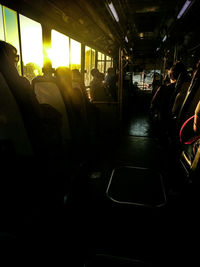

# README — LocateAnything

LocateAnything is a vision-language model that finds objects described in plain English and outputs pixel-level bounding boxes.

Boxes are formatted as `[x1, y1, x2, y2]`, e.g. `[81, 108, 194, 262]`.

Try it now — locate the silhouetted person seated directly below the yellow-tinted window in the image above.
[90, 69, 110, 101]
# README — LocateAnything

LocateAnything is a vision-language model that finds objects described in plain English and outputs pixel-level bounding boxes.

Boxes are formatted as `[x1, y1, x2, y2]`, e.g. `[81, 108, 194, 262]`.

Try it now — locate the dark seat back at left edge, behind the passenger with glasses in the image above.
[0, 73, 33, 156]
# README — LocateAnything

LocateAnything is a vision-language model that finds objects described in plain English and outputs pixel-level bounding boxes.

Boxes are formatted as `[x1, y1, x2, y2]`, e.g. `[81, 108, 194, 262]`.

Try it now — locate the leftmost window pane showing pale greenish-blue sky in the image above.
[3, 7, 21, 74]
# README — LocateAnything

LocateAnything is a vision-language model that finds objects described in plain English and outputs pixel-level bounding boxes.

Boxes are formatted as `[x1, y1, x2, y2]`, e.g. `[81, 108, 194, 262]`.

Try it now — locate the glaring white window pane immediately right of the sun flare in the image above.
[50, 30, 69, 68]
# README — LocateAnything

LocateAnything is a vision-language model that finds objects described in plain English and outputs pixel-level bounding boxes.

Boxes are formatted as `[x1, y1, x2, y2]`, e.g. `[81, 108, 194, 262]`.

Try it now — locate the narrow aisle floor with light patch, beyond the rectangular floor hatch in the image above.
[115, 91, 164, 170]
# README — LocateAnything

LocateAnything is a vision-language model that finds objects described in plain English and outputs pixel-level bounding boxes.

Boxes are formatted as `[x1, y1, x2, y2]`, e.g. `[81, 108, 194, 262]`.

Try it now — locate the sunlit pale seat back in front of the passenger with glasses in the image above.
[32, 78, 71, 148]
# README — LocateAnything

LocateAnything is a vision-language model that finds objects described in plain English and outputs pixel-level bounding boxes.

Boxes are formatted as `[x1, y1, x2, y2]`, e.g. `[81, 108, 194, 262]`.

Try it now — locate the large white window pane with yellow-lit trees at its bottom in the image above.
[20, 15, 43, 81]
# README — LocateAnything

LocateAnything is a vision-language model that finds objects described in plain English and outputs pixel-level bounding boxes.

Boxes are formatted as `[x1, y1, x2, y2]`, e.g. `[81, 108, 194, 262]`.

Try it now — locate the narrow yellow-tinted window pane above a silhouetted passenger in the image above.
[85, 46, 95, 86]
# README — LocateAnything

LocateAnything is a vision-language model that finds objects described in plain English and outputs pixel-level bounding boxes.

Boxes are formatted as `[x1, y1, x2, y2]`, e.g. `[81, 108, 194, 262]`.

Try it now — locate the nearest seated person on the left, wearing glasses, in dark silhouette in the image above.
[0, 41, 62, 156]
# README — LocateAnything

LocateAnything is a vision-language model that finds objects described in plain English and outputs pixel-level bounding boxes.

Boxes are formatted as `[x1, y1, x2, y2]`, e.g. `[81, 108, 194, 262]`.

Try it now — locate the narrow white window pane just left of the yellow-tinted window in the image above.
[70, 39, 81, 70]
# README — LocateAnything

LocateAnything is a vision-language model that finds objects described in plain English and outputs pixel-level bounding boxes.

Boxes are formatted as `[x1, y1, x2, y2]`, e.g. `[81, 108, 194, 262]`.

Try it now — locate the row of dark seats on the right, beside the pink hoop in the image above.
[155, 62, 200, 184]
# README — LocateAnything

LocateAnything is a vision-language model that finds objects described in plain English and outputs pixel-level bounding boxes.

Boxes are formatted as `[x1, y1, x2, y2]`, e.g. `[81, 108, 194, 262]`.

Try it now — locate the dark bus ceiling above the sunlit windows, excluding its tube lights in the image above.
[2, 0, 200, 63]
